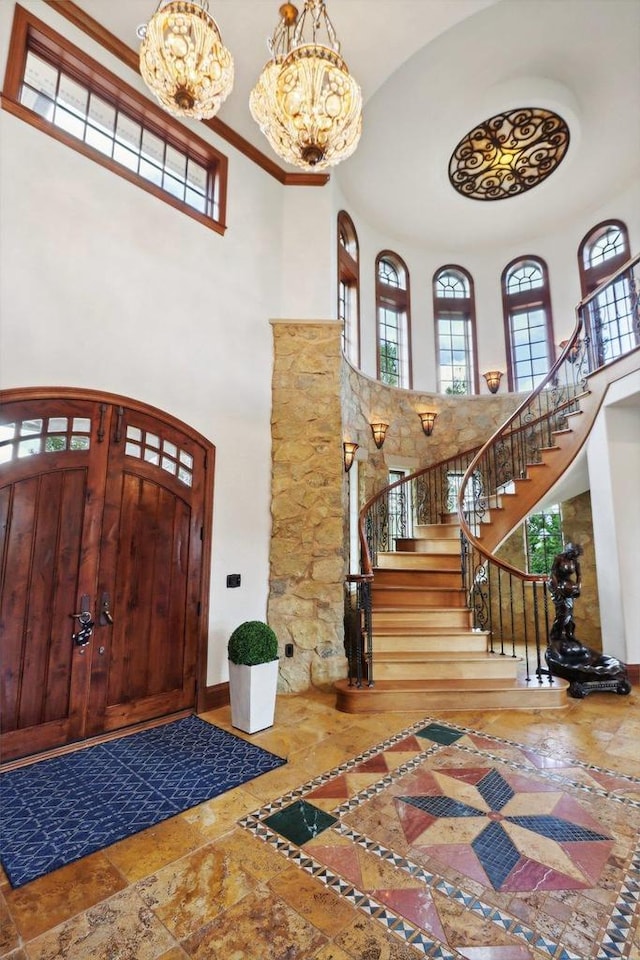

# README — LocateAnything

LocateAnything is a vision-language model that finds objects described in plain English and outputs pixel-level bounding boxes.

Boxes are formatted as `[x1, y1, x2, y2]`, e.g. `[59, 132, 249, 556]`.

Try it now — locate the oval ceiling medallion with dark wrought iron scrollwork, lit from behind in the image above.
[449, 107, 569, 200]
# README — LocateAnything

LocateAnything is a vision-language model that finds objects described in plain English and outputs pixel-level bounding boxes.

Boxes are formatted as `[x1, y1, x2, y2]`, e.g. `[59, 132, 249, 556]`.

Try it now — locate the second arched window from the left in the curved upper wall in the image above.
[376, 250, 411, 387]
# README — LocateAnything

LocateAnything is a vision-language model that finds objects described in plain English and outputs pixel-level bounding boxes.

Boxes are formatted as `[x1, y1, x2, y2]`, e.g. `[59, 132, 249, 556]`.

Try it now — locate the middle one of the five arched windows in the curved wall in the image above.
[433, 266, 478, 394]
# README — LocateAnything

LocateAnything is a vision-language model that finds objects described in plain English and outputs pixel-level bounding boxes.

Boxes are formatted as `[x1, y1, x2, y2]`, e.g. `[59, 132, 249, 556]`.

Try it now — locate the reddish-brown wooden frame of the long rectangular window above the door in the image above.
[1, 5, 228, 234]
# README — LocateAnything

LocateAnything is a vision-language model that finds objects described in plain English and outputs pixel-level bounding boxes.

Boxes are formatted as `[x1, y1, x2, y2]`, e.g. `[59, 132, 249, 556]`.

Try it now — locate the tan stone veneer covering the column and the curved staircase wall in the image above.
[267, 338, 599, 692]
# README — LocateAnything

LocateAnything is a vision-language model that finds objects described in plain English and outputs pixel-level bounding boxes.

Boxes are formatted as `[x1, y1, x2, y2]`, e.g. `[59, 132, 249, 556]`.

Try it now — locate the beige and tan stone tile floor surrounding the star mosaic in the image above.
[0, 690, 640, 960]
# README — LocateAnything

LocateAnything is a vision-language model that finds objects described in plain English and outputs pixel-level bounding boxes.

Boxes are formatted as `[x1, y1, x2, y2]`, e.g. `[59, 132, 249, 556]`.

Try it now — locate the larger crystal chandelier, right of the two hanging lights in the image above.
[249, 0, 362, 170]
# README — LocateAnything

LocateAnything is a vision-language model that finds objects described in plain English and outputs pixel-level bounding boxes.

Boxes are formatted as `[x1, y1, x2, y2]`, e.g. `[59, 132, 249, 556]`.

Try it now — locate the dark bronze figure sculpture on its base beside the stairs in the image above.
[545, 543, 631, 699]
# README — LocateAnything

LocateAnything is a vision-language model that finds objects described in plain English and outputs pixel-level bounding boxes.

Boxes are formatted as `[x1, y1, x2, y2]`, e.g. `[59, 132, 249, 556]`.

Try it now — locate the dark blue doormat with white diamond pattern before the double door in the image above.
[0, 716, 286, 888]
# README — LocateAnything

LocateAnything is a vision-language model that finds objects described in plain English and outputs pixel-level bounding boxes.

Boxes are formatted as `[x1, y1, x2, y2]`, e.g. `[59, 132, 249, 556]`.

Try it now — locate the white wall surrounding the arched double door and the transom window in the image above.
[0, 3, 284, 683]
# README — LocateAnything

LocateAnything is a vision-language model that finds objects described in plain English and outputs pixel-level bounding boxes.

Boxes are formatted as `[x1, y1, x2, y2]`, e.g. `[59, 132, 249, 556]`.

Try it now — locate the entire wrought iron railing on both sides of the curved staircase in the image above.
[345, 257, 640, 686]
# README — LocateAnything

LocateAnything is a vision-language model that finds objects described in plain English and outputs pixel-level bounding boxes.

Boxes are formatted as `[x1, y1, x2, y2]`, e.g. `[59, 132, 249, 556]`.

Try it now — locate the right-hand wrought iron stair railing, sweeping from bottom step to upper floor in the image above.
[457, 251, 640, 683]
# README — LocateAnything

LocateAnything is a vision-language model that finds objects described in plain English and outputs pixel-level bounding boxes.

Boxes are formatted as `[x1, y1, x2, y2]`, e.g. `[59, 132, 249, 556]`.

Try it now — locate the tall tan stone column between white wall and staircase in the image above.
[267, 320, 347, 692]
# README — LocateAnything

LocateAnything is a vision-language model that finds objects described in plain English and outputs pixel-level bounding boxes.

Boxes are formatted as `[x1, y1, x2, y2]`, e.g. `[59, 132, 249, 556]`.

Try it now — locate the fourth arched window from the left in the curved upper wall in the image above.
[502, 257, 555, 391]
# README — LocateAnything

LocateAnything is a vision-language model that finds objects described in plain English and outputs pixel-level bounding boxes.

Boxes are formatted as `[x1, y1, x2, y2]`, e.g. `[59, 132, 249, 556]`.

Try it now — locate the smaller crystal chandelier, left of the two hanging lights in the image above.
[138, 0, 233, 120]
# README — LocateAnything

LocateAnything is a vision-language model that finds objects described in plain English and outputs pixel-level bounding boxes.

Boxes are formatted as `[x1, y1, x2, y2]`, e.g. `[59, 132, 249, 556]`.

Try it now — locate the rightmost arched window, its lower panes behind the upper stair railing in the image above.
[578, 220, 638, 364]
